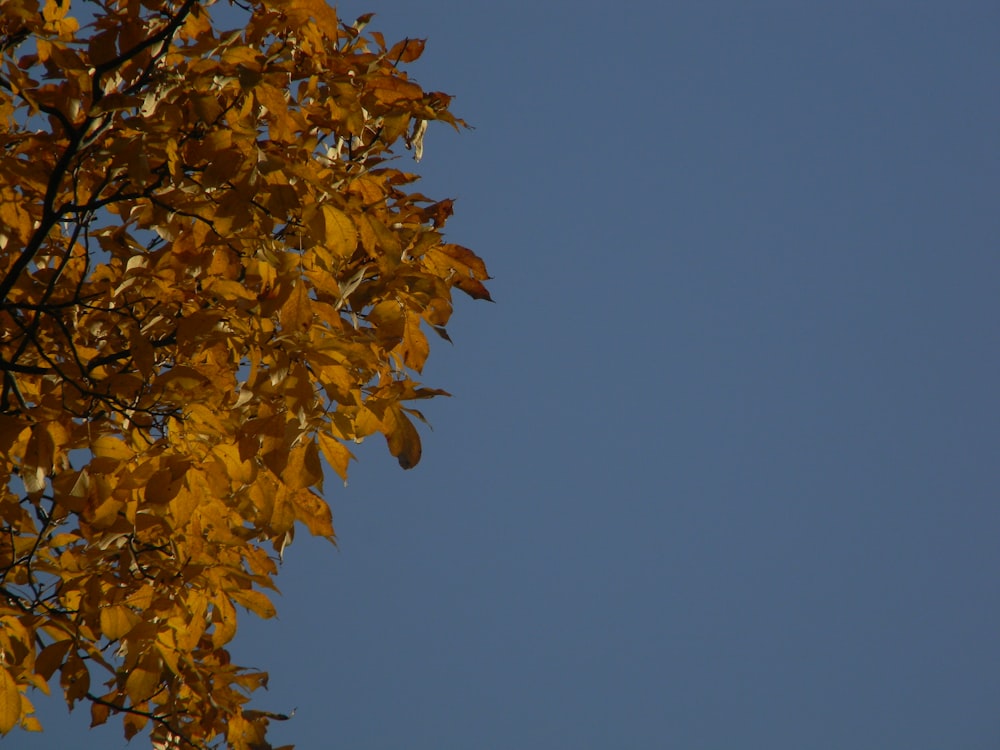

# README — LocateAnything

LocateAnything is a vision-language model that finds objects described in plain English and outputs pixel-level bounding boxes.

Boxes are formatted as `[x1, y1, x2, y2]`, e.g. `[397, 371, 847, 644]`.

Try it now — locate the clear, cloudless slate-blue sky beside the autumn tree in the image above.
[19, 0, 1000, 750]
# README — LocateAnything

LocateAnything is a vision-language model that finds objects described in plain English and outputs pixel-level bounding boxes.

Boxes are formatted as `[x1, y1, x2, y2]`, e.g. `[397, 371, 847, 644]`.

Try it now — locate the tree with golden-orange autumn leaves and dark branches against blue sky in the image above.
[0, 0, 489, 749]
